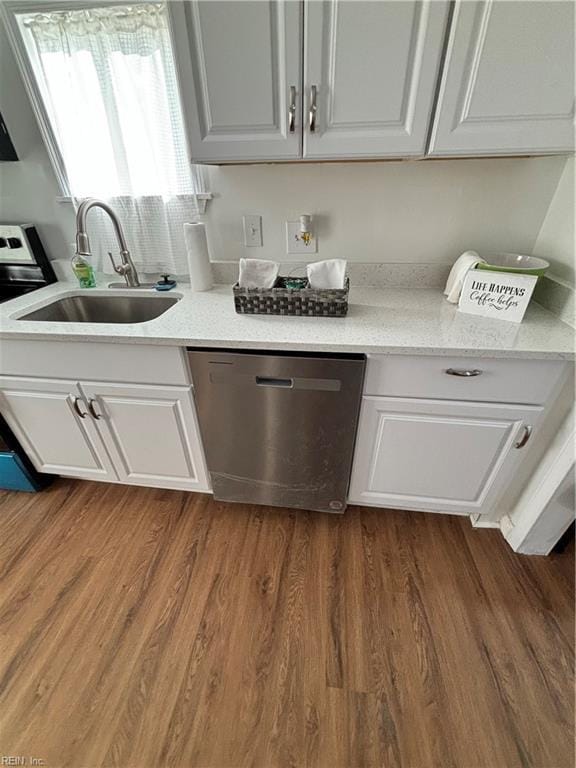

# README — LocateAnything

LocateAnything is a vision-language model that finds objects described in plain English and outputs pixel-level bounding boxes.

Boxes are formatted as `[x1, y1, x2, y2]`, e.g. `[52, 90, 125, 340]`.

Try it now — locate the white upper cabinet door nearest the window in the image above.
[169, 0, 302, 163]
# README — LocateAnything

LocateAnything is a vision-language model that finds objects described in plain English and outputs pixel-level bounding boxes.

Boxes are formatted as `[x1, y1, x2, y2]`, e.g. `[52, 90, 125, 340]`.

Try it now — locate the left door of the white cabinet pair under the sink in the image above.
[0, 376, 118, 481]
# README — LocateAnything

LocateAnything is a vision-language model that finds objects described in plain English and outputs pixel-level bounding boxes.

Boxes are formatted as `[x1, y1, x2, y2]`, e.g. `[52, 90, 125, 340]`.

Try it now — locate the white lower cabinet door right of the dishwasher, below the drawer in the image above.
[349, 397, 542, 514]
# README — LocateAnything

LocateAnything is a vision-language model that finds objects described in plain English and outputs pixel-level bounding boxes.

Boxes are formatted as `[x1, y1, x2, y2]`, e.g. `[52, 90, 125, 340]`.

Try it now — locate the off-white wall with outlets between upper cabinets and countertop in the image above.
[206, 157, 565, 263]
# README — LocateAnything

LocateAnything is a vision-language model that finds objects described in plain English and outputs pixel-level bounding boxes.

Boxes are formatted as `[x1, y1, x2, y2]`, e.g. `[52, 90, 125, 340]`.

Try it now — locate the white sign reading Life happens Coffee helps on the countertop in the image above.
[458, 269, 538, 323]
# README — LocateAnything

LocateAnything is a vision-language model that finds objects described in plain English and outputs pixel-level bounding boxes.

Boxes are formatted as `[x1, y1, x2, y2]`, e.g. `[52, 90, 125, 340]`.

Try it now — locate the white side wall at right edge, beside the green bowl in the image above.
[533, 157, 576, 287]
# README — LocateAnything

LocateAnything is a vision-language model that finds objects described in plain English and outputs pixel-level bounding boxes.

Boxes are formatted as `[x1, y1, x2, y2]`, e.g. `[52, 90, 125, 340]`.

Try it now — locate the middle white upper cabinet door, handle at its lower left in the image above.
[304, 0, 448, 159]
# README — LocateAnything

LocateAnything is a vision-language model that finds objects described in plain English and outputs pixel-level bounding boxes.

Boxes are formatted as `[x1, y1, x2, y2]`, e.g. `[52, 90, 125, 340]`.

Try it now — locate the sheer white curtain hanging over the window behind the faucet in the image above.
[21, 3, 205, 275]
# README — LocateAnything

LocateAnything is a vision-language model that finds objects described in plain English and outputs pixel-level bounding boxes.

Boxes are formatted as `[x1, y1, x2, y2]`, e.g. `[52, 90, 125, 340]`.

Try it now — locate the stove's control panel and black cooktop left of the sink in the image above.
[0, 224, 57, 303]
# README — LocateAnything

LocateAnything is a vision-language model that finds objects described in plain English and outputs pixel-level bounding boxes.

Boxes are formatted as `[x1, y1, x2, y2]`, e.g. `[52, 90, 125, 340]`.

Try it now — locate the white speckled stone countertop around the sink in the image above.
[0, 283, 575, 360]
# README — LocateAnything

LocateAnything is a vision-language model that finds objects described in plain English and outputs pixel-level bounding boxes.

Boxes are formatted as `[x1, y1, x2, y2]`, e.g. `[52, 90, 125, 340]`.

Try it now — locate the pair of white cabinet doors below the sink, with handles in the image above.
[0, 376, 210, 491]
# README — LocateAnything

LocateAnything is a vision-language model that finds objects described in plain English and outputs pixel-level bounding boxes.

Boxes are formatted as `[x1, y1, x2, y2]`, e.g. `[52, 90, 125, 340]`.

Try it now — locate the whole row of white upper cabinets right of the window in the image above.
[169, 0, 574, 163]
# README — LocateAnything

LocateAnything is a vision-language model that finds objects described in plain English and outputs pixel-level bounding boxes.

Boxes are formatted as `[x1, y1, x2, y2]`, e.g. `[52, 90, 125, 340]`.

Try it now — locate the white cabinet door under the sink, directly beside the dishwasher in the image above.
[81, 382, 210, 491]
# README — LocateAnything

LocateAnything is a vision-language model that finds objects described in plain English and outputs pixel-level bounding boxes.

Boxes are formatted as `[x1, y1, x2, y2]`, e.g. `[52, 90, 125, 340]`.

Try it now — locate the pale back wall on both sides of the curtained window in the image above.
[0, 18, 565, 272]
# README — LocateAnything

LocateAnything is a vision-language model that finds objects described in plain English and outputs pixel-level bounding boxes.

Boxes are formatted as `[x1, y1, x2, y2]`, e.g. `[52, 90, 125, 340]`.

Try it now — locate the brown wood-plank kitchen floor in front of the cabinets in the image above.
[0, 480, 574, 768]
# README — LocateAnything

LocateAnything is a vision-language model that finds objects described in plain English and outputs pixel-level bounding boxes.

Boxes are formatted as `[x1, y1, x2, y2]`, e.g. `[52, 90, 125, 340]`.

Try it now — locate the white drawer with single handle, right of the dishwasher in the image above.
[364, 355, 566, 405]
